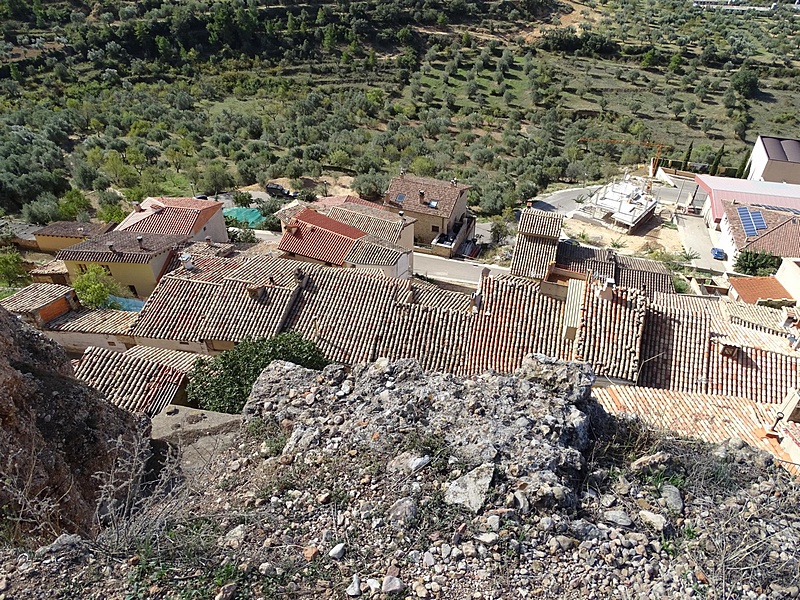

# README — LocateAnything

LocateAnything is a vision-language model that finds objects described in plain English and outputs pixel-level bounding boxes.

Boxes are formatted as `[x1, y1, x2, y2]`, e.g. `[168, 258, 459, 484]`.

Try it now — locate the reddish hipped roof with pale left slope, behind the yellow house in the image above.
[117, 198, 222, 237]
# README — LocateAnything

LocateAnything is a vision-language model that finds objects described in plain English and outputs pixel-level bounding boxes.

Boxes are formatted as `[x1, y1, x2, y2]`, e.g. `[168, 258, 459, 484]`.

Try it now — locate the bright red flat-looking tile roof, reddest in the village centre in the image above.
[278, 209, 366, 266]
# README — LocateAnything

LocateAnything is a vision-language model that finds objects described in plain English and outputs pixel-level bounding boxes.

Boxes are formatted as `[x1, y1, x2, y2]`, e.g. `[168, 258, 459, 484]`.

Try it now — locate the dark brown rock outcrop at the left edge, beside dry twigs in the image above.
[0, 308, 142, 535]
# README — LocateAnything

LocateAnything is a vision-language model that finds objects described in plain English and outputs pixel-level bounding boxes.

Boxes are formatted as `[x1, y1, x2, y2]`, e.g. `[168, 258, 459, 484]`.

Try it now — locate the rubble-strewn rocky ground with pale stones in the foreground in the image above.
[0, 356, 800, 600]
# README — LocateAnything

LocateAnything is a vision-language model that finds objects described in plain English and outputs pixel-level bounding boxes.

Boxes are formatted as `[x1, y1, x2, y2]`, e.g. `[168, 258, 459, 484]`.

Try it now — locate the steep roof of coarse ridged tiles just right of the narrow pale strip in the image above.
[574, 283, 648, 382]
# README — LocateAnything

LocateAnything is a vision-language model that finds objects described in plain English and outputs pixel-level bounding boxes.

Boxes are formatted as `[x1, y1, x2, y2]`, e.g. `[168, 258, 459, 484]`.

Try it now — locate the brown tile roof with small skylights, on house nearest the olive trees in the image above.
[384, 175, 471, 219]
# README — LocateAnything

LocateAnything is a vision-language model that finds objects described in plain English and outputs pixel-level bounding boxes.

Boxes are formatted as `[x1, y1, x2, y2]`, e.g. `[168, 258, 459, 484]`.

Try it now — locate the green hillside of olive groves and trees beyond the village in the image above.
[0, 0, 800, 220]
